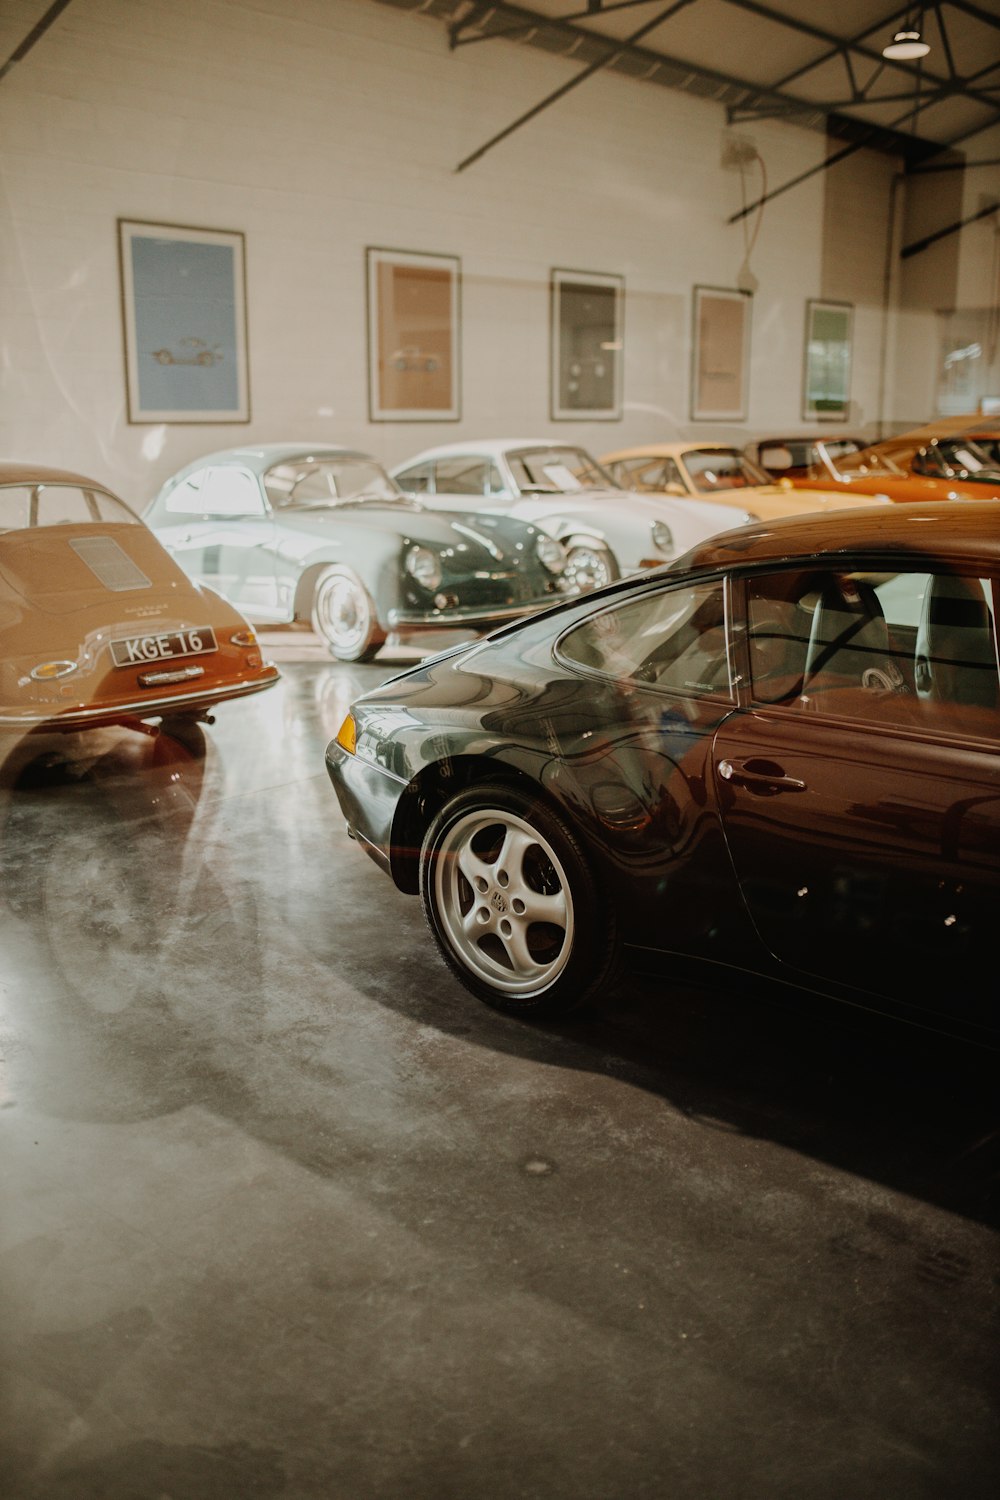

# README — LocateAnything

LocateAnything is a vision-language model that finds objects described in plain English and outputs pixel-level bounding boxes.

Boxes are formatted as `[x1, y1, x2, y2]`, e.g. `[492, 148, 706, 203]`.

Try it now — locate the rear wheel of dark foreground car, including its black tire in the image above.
[420, 782, 618, 1017]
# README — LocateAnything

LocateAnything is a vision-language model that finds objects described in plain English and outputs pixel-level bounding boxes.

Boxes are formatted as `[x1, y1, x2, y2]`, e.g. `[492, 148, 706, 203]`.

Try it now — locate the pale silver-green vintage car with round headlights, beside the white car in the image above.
[144, 443, 565, 662]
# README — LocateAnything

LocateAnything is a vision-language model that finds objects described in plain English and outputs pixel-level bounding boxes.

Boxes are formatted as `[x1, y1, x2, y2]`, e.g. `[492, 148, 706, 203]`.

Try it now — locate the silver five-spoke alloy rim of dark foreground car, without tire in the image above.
[432, 807, 574, 996]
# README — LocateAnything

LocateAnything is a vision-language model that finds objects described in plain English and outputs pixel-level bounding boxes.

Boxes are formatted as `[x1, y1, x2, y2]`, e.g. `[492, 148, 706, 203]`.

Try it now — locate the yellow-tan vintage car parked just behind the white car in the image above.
[601, 441, 885, 521]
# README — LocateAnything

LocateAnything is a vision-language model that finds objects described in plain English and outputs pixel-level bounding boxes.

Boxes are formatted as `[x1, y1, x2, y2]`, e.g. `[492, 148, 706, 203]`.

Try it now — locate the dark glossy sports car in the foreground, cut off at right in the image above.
[327, 501, 1000, 1046]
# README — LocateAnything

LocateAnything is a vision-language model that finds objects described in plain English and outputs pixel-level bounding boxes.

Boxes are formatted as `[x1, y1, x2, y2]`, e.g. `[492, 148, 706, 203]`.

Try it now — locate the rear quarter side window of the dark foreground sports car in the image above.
[558, 581, 733, 699]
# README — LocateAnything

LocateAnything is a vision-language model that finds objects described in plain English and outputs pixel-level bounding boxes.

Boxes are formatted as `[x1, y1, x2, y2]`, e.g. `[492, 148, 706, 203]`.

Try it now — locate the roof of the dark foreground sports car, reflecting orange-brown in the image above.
[682, 500, 1000, 570]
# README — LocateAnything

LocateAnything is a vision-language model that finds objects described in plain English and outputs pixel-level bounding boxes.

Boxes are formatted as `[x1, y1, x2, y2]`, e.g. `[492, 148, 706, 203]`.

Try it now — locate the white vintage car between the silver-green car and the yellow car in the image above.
[391, 438, 757, 590]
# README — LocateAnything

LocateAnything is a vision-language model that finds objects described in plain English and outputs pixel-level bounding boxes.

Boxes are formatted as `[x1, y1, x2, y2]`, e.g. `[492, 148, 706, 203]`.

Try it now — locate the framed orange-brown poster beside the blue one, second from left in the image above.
[366, 246, 462, 422]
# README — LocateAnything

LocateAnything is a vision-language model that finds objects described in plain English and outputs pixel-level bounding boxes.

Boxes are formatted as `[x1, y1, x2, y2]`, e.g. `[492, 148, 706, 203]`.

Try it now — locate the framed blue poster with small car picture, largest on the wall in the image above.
[118, 219, 250, 423]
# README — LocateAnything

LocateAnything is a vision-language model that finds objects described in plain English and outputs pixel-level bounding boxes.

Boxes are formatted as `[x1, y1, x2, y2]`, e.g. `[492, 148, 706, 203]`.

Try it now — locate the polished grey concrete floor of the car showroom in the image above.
[0, 632, 1000, 1500]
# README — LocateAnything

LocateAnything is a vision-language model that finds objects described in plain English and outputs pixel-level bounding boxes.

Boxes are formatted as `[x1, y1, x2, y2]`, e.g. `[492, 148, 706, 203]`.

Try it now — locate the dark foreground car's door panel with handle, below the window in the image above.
[714, 708, 1000, 1022]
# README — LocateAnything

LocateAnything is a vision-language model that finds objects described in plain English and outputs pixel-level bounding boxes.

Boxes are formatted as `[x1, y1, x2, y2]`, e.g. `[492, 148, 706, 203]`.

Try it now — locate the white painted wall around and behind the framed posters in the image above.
[0, 0, 983, 503]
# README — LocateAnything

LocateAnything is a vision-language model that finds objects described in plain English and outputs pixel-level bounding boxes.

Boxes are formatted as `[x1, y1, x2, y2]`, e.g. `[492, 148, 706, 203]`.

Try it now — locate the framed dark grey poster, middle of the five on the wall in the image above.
[550, 270, 625, 422]
